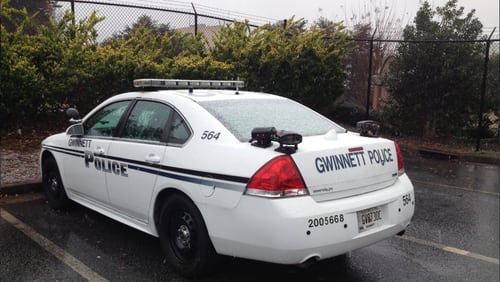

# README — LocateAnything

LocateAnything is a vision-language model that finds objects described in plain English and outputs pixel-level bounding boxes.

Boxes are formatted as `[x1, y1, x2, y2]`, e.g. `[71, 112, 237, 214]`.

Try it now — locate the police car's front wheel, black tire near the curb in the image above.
[42, 157, 71, 210]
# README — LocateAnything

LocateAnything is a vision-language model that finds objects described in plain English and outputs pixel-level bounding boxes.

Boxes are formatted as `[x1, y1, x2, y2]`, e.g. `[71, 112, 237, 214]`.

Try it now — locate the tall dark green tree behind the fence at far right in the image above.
[386, 0, 483, 137]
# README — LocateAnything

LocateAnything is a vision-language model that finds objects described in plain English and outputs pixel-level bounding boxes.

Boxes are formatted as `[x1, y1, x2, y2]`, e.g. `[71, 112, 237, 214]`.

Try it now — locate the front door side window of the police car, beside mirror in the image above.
[84, 101, 130, 137]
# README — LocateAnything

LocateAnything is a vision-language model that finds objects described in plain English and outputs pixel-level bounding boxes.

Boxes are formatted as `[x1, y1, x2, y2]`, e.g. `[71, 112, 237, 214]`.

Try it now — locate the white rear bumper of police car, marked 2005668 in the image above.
[202, 175, 415, 264]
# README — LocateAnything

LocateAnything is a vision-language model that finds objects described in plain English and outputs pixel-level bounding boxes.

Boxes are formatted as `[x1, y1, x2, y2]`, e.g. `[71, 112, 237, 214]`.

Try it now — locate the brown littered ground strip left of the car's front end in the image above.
[0, 148, 41, 187]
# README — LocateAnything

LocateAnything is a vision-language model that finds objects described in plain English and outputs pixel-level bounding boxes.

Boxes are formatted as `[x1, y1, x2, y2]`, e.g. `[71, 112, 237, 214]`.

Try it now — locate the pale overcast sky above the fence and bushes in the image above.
[187, 0, 499, 33]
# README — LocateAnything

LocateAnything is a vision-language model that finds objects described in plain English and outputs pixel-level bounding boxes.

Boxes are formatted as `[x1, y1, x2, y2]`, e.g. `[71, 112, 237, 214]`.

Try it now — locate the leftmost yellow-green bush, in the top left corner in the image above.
[0, 5, 102, 125]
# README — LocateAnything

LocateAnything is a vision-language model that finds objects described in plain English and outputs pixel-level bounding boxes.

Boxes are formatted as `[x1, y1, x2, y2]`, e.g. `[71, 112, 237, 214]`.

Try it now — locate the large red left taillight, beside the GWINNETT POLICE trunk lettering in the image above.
[245, 155, 307, 198]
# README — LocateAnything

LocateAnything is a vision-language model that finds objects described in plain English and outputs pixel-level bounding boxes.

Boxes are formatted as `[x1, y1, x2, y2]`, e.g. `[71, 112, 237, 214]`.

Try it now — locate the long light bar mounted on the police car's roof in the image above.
[134, 78, 245, 89]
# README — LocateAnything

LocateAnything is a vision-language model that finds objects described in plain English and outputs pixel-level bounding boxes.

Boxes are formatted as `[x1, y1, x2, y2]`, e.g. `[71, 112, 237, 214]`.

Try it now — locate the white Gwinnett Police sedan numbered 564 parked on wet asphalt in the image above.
[40, 79, 415, 277]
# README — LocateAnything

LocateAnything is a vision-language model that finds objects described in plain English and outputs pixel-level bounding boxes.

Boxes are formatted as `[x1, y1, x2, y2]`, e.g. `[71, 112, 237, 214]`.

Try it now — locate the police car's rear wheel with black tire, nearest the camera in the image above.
[159, 194, 217, 278]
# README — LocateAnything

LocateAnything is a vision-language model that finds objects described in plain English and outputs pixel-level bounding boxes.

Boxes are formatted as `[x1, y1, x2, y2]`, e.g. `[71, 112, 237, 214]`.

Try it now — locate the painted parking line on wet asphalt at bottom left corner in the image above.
[0, 209, 108, 281]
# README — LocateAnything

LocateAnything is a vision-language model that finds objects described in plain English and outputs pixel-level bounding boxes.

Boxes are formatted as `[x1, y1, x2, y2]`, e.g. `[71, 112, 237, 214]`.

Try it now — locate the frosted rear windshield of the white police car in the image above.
[200, 99, 345, 142]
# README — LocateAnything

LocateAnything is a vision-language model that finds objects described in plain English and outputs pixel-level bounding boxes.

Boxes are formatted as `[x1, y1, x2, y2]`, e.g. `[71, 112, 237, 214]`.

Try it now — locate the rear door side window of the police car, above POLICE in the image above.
[122, 101, 172, 142]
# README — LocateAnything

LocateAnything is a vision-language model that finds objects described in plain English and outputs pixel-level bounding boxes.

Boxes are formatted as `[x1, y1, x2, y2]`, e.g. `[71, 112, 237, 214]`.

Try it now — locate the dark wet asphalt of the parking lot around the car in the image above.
[0, 155, 500, 281]
